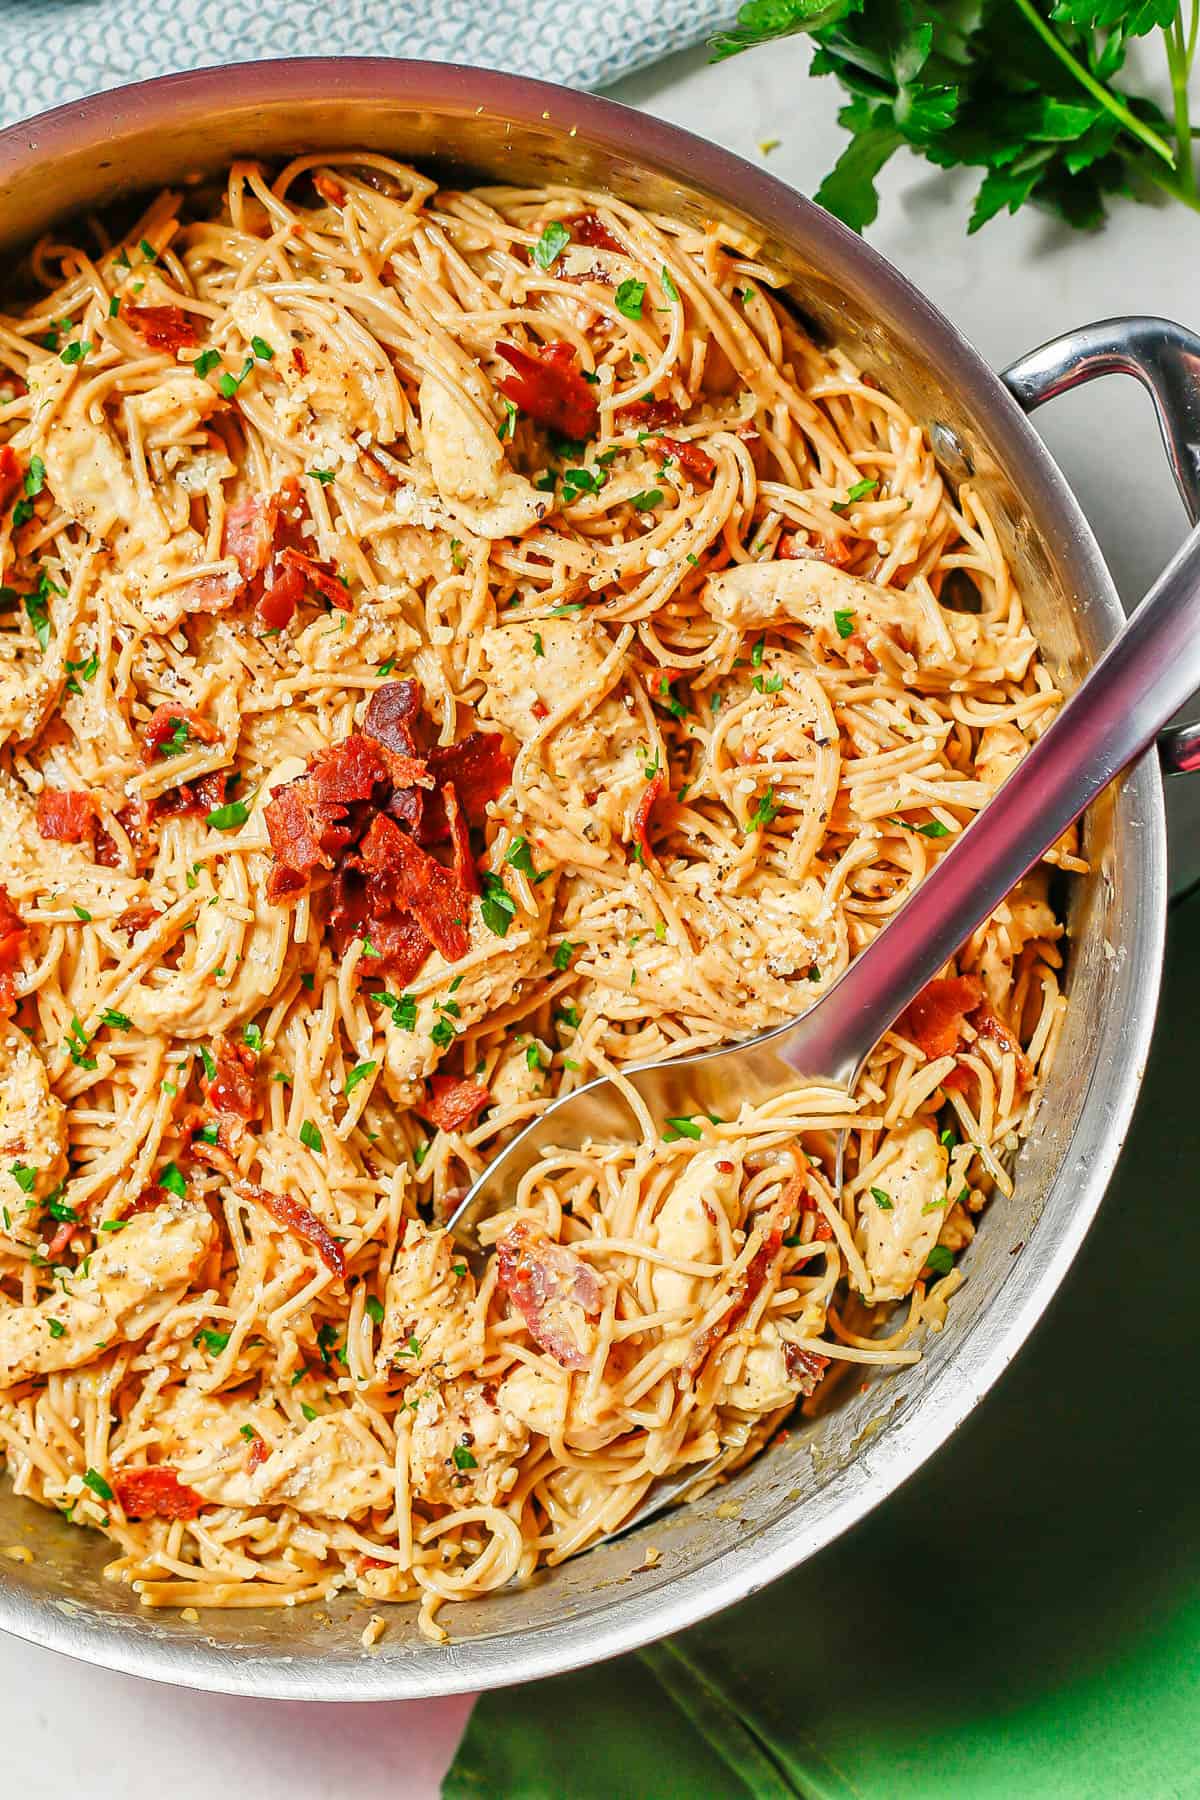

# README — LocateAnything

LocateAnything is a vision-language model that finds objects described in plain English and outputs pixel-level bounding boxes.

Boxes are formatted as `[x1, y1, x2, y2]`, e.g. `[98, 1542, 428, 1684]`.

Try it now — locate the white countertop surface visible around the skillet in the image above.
[0, 38, 1200, 1800]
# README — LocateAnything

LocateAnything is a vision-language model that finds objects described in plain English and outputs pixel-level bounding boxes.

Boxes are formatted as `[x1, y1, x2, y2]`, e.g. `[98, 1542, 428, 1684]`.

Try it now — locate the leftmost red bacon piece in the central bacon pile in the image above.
[263, 731, 387, 902]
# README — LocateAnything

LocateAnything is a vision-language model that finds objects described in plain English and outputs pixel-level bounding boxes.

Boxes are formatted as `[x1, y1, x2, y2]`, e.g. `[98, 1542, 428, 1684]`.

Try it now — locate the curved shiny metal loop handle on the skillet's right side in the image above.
[1000, 319, 1200, 776]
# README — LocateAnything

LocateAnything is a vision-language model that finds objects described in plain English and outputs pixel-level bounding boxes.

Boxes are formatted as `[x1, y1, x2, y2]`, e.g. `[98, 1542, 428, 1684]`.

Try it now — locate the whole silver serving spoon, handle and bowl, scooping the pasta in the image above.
[450, 527, 1200, 1532]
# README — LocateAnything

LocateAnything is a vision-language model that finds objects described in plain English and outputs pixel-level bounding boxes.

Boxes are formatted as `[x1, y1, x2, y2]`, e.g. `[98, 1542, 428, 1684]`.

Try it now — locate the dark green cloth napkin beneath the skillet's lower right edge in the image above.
[443, 898, 1200, 1800]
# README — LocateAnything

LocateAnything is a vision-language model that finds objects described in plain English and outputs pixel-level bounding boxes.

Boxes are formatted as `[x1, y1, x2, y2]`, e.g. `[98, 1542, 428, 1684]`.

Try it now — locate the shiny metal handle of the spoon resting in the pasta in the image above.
[772, 527, 1200, 1080]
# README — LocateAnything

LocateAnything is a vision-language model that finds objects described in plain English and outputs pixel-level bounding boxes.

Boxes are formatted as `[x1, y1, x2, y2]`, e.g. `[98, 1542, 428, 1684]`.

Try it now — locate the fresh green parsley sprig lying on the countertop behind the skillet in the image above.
[712, 0, 1200, 232]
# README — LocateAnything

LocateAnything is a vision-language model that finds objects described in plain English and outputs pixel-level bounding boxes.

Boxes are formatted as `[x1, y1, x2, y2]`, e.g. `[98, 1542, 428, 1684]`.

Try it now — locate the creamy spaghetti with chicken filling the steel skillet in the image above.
[0, 153, 1083, 1636]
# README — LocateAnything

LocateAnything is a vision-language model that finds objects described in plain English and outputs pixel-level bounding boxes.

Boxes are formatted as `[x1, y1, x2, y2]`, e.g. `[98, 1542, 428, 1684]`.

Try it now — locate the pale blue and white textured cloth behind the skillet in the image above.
[0, 0, 738, 124]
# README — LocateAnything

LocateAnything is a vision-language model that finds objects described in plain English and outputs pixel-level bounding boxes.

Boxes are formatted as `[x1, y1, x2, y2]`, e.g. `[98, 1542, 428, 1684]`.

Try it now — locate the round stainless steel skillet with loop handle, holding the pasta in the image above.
[0, 59, 1200, 1699]
